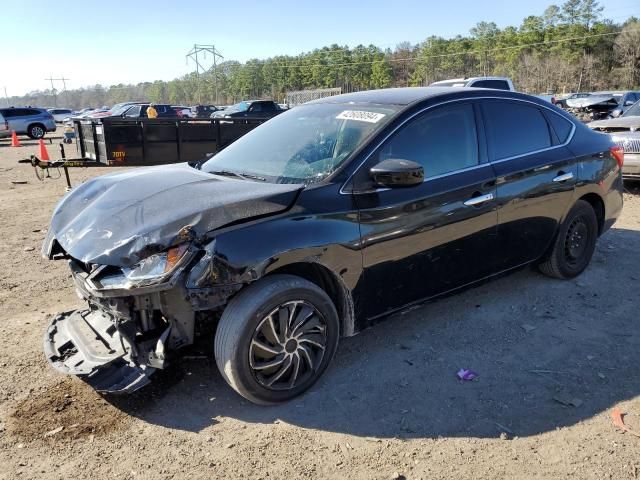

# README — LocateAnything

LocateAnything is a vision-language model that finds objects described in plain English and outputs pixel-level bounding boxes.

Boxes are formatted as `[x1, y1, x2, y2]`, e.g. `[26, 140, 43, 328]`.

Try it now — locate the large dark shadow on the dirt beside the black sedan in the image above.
[109, 229, 640, 438]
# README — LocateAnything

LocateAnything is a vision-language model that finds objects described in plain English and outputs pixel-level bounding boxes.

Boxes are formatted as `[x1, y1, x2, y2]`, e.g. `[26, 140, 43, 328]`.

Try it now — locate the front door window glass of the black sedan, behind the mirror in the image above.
[378, 104, 479, 178]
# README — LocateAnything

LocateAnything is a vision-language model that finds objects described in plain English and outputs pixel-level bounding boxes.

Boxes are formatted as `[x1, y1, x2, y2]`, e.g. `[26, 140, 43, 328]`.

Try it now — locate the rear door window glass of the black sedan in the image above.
[483, 101, 552, 160]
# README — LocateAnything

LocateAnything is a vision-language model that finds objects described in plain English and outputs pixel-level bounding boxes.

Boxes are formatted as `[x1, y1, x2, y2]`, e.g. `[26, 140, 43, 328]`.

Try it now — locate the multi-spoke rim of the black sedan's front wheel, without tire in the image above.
[249, 300, 327, 390]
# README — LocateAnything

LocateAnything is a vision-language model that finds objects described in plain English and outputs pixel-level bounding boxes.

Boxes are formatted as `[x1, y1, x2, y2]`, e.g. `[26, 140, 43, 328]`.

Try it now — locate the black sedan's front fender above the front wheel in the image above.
[187, 184, 363, 336]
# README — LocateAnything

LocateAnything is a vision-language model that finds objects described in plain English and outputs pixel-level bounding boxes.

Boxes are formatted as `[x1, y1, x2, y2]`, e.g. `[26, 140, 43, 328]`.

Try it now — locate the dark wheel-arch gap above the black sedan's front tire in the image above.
[265, 262, 355, 337]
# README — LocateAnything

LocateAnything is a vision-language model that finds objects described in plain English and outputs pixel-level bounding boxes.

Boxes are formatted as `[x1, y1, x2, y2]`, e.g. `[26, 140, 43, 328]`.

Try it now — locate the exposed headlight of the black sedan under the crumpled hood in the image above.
[88, 243, 189, 290]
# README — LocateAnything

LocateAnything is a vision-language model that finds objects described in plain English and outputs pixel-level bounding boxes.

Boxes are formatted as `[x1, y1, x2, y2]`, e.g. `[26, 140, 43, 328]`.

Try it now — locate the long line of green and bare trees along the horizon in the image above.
[8, 0, 640, 109]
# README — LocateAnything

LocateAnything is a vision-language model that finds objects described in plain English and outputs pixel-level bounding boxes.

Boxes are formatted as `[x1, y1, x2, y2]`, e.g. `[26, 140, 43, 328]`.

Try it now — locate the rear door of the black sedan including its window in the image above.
[482, 99, 577, 269]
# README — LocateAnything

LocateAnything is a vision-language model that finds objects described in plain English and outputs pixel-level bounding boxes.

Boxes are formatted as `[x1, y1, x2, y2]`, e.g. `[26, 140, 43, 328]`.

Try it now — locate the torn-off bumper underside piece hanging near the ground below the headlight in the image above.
[44, 310, 161, 393]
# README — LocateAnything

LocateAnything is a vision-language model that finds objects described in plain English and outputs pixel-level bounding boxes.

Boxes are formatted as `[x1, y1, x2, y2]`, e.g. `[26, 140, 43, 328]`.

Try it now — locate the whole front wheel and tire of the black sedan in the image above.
[215, 275, 339, 405]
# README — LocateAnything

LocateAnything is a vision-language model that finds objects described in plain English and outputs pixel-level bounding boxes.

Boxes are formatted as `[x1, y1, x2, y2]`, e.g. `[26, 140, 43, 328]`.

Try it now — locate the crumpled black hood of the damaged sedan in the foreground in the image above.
[43, 163, 302, 267]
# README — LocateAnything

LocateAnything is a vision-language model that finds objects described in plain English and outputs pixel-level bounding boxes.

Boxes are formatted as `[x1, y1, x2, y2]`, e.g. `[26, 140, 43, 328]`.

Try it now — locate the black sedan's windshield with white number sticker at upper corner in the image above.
[202, 104, 398, 185]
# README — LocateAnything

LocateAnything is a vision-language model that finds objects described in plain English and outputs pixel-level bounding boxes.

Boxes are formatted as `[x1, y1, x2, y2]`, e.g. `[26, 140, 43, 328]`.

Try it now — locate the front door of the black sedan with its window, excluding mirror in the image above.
[354, 102, 497, 318]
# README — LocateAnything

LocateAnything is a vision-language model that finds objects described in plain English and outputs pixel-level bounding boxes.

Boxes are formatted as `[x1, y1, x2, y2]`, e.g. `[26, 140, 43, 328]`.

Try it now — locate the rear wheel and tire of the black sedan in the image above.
[538, 200, 598, 279]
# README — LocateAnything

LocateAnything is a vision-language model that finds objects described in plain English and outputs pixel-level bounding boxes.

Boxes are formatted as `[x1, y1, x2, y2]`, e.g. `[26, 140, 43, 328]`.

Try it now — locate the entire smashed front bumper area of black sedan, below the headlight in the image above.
[44, 251, 240, 393]
